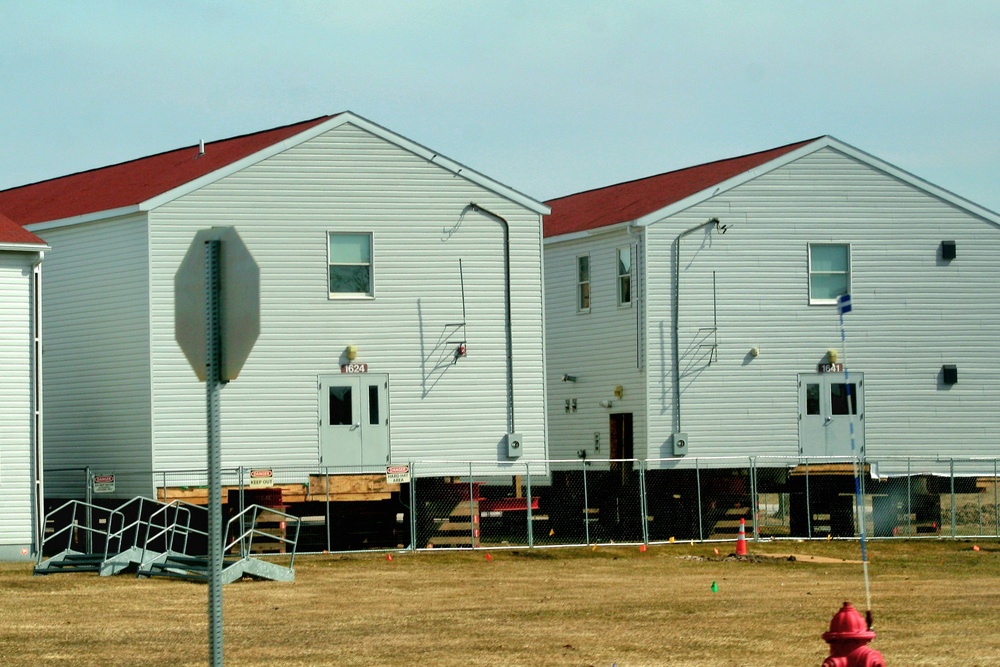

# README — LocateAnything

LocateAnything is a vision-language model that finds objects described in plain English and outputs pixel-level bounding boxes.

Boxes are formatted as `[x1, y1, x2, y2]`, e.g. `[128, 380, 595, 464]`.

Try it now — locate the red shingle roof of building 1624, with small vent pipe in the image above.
[0, 116, 332, 225]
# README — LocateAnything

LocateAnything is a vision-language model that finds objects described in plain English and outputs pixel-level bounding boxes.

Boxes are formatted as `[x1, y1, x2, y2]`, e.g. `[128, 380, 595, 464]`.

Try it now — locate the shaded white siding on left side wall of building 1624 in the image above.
[39, 215, 154, 498]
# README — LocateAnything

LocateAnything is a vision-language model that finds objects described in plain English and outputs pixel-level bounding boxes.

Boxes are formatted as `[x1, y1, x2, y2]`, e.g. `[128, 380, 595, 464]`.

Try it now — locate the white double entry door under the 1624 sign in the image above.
[319, 374, 389, 468]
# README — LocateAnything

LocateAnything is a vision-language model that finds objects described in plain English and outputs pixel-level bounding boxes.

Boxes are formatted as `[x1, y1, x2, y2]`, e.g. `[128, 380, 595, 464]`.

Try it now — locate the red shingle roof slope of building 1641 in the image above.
[544, 139, 815, 237]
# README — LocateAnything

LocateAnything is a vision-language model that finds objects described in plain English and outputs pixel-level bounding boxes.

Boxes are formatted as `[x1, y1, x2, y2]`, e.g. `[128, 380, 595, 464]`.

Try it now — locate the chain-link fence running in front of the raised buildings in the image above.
[39, 457, 1000, 553]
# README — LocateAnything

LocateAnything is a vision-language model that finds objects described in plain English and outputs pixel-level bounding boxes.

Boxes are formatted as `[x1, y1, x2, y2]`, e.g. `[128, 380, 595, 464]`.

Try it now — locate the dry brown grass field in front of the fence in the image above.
[0, 540, 1000, 667]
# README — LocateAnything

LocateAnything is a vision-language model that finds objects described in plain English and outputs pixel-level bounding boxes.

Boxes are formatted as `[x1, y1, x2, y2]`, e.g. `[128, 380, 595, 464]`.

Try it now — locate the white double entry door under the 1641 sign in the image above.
[799, 373, 865, 456]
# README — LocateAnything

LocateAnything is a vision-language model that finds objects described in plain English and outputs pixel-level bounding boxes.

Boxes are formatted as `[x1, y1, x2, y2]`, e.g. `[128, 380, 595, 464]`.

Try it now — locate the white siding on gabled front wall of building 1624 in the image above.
[150, 124, 546, 470]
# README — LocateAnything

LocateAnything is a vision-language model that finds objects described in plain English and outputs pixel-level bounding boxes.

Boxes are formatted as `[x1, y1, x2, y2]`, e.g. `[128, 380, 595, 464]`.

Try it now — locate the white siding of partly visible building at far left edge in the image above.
[0, 250, 38, 560]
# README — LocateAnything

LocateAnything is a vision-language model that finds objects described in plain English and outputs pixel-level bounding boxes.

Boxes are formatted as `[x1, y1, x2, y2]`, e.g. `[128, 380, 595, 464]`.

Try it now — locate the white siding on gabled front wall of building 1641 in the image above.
[640, 148, 1000, 465]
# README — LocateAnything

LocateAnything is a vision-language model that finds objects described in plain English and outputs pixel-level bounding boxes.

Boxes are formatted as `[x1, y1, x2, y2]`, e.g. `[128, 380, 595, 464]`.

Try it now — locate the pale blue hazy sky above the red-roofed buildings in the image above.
[0, 0, 1000, 211]
